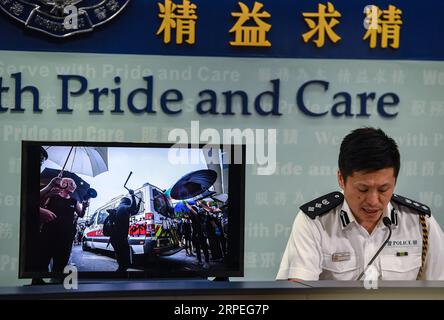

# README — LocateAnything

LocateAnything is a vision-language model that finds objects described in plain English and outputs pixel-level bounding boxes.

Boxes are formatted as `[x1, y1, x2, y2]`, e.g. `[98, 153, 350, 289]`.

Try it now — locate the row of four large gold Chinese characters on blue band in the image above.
[156, 0, 403, 49]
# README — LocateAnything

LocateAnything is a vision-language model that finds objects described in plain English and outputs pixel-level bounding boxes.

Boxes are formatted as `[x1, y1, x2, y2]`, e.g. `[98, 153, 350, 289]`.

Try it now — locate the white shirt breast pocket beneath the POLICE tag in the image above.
[381, 253, 421, 280]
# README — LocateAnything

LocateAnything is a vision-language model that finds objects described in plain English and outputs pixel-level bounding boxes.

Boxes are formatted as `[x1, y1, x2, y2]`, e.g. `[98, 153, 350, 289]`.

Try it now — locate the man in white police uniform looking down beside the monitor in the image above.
[276, 128, 444, 281]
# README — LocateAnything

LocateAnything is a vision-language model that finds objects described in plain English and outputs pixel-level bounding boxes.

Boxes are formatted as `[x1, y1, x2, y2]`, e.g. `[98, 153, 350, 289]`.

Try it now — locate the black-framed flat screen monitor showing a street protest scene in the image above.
[19, 141, 245, 278]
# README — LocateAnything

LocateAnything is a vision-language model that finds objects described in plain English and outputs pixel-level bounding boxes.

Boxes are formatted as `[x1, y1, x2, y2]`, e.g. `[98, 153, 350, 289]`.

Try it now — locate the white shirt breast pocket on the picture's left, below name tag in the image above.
[319, 254, 358, 280]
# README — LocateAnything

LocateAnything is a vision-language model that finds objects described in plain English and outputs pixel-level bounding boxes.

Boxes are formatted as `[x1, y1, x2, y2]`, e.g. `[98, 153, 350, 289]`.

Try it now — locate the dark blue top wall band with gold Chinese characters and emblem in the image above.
[0, 0, 444, 60]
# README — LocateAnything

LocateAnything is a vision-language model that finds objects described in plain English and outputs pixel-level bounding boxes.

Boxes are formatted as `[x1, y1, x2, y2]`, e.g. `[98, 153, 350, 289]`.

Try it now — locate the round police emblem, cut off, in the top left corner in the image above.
[0, 0, 130, 38]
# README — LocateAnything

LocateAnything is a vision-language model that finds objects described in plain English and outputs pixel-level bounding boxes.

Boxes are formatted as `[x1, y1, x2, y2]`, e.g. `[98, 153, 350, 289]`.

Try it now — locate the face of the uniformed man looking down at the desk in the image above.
[338, 168, 396, 226]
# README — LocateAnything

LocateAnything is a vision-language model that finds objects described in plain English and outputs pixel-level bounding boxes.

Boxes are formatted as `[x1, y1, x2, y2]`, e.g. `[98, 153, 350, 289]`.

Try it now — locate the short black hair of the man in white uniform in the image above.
[338, 127, 401, 181]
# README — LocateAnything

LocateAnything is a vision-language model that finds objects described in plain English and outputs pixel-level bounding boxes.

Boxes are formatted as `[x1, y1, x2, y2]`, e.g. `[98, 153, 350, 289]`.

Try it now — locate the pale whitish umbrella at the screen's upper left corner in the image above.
[45, 146, 108, 177]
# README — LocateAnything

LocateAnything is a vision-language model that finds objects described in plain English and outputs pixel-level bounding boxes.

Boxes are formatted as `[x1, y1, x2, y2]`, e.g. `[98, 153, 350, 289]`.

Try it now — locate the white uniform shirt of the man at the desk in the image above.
[276, 199, 444, 281]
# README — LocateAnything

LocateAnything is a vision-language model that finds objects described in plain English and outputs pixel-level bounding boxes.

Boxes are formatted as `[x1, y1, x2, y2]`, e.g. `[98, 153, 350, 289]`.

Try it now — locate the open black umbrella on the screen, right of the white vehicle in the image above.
[170, 169, 217, 200]
